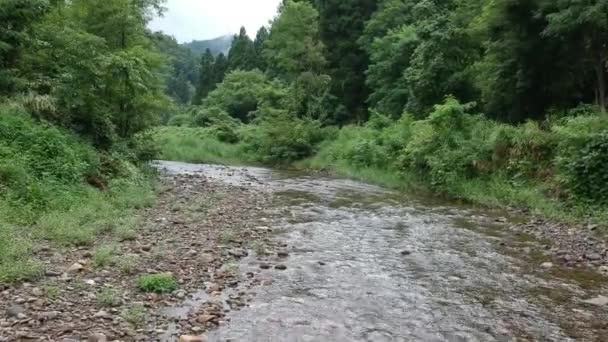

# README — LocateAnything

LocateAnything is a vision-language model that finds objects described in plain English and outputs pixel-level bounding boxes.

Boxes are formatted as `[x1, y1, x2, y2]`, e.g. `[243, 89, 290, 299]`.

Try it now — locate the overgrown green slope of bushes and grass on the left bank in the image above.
[0, 105, 155, 283]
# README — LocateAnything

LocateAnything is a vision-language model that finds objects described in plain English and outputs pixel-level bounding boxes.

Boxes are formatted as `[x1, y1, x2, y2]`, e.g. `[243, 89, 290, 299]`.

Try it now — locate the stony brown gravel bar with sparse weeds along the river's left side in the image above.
[0, 169, 283, 342]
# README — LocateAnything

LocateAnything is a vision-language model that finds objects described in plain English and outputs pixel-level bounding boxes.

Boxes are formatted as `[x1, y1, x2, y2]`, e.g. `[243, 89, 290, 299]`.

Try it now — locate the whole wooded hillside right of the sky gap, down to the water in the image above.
[157, 0, 608, 224]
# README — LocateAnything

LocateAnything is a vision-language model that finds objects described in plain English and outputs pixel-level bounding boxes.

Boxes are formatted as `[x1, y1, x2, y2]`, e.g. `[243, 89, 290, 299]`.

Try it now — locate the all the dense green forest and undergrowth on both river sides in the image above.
[0, 0, 608, 281]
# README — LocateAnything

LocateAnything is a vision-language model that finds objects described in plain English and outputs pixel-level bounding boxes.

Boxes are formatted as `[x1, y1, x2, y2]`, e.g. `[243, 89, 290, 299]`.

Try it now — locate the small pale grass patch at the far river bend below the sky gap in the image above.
[155, 127, 251, 165]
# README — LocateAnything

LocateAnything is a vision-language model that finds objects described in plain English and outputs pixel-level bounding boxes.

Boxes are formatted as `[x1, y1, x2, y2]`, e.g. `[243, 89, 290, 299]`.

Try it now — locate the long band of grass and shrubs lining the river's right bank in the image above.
[157, 99, 608, 228]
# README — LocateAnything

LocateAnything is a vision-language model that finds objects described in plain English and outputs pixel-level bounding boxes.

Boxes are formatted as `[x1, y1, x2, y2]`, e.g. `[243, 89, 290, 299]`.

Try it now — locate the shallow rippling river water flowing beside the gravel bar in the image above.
[161, 162, 608, 341]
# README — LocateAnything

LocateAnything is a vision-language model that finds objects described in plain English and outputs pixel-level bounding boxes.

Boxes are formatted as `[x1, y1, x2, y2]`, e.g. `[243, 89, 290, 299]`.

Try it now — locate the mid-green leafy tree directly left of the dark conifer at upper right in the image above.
[404, 0, 480, 116]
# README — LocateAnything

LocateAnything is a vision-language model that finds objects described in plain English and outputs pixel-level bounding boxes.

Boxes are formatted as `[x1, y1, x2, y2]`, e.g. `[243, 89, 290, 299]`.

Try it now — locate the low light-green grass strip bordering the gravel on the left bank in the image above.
[0, 175, 156, 283]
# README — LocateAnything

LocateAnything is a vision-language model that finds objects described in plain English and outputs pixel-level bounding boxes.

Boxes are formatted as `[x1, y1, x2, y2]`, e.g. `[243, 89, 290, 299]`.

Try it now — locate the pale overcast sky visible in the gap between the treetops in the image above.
[149, 0, 281, 43]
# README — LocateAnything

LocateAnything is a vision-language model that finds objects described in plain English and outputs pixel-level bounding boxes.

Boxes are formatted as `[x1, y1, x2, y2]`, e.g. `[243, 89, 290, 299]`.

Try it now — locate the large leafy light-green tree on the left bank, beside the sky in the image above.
[19, 0, 169, 148]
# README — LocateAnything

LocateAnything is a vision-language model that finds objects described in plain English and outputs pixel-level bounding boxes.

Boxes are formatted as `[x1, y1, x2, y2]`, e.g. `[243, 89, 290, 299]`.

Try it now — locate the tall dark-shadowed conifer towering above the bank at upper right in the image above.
[475, 0, 588, 122]
